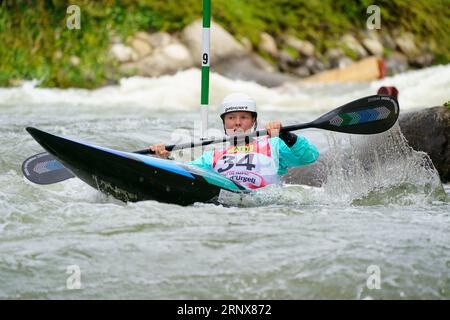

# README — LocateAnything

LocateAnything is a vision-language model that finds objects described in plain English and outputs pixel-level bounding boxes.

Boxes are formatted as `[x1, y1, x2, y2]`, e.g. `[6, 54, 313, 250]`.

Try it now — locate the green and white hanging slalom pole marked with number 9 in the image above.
[200, 0, 211, 140]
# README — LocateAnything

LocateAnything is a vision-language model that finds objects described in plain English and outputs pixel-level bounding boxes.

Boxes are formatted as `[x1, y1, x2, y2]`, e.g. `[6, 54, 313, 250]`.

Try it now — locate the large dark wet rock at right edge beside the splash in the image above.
[399, 107, 450, 182]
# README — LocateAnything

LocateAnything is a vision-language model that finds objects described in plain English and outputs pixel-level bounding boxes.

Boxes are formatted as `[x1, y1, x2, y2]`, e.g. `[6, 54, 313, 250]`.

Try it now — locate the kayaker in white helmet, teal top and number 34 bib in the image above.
[150, 93, 319, 189]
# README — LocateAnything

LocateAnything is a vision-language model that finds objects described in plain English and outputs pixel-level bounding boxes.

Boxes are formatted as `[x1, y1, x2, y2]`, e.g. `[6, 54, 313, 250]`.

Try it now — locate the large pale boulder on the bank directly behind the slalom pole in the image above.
[181, 20, 247, 67]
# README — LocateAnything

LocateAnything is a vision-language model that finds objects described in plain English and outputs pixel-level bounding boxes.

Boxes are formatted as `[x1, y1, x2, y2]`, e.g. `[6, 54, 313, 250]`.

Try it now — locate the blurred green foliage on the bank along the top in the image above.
[0, 0, 450, 88]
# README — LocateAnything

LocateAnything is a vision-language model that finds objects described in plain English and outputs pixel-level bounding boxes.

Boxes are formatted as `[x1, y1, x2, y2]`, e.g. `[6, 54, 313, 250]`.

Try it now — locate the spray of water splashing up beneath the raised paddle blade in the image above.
[323, 123, 446, 205]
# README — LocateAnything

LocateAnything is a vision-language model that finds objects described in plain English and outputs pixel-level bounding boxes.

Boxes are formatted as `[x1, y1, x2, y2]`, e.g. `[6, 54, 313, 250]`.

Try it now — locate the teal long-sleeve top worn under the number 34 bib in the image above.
[189, 136, 319, 176]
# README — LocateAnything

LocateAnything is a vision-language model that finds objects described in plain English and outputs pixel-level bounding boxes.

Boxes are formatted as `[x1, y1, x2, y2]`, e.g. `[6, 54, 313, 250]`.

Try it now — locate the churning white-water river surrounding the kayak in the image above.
[0, 66, 450, 299]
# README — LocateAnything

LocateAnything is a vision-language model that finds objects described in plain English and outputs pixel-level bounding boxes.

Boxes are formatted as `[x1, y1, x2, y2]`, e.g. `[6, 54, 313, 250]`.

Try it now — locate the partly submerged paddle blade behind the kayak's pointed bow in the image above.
[22, 152, 74, 184]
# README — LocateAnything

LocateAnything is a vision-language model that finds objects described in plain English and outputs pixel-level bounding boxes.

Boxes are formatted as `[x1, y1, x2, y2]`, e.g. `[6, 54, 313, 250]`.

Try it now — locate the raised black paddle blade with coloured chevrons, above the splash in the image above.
[311, 95, 400, 134]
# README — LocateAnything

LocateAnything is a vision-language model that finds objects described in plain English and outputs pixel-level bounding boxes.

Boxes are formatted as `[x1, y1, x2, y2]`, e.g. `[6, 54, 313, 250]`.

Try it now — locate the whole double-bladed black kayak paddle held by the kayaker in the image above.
[22, 95, 399, 184]
